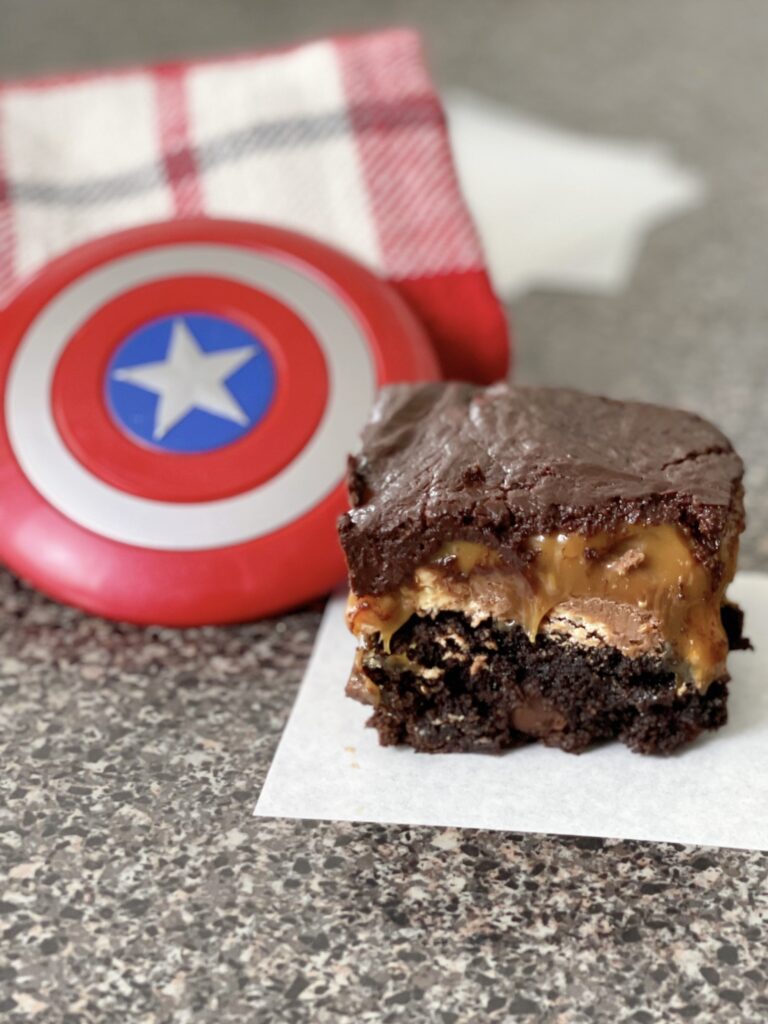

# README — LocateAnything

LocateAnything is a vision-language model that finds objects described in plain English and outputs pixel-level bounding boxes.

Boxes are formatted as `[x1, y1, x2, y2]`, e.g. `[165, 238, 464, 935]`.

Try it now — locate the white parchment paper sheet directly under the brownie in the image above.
[256, 573, 768, 850]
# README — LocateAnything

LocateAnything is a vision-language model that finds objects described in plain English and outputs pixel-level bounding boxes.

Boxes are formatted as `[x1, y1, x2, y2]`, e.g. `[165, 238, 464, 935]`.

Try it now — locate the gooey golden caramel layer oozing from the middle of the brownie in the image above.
[347, 524, 737, 690]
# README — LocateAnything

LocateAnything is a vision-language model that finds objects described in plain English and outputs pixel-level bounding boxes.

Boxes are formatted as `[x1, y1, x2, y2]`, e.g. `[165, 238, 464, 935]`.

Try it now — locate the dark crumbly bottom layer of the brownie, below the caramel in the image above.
[356, 612, 744, 754]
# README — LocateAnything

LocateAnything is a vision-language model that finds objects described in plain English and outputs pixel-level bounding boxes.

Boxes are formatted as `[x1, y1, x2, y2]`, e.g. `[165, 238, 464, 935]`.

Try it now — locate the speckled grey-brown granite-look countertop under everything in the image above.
[0, 0, 768, 1024]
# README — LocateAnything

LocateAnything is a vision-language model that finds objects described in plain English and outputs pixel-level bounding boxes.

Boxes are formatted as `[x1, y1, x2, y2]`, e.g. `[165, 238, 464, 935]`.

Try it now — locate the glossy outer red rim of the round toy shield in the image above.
[0, 218, 439, 626]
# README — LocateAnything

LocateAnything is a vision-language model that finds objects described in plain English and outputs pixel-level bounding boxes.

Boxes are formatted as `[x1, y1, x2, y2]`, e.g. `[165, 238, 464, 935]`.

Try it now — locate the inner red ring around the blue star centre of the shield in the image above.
[51, 275, 328, 502]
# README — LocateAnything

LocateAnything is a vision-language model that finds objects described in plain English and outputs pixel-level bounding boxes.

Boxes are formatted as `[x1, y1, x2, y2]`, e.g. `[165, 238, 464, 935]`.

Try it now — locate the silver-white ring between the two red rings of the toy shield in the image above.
[5, 243, 376, 551]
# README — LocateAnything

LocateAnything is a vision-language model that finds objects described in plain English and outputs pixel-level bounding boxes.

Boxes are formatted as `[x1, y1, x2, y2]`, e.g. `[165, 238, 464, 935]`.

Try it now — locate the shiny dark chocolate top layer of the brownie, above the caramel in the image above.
[339, 383, 743, 594]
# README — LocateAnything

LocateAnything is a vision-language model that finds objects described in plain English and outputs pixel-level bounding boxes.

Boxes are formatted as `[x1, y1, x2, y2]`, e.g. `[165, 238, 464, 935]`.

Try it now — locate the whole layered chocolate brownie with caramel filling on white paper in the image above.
[339, 384, 743, 753]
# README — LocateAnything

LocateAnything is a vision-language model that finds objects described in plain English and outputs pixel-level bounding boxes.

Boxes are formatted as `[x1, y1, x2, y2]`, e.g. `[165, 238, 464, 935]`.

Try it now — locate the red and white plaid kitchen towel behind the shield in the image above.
[0, 30, 507, 382]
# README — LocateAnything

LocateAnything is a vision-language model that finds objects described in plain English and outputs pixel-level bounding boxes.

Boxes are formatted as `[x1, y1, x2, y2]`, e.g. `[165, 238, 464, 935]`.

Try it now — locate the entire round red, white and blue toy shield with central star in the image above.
[0, 220, 439, 625]
